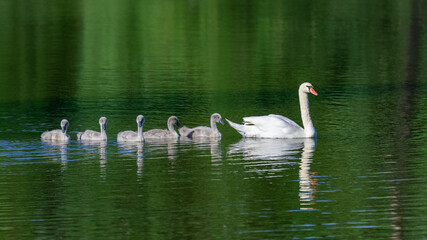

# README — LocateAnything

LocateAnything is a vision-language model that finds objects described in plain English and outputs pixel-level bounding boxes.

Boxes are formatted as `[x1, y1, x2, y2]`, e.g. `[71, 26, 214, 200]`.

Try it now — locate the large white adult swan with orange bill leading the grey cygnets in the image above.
[226, 82, 317, 138]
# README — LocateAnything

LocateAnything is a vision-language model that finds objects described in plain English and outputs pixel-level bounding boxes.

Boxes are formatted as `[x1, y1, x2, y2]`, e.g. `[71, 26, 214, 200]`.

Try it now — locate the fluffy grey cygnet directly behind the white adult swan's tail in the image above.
[179, 113, 224, 138]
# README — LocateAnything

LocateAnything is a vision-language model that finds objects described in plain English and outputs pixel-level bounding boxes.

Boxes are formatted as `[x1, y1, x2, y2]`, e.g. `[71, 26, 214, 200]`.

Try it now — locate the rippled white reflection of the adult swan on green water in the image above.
[228, 138, 317, 210]
